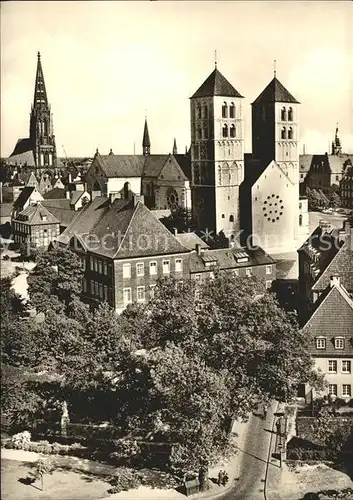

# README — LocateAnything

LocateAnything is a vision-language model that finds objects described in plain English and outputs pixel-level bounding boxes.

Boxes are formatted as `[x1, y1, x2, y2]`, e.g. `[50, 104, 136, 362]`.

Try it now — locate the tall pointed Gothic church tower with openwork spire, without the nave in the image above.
[29, 52, 57, 170]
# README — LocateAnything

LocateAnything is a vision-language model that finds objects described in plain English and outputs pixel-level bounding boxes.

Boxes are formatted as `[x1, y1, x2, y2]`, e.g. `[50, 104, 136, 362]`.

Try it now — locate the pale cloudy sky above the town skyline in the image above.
[1, 0, 353, 157]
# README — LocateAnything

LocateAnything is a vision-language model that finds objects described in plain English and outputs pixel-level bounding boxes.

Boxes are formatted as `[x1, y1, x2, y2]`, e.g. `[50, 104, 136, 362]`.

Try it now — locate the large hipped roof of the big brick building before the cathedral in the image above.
[58, 197, 188, 259]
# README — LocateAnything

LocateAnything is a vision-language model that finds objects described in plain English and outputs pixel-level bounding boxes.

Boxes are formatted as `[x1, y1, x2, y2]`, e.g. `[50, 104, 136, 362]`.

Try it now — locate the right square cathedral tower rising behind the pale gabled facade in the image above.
[252, 72, 300, 189]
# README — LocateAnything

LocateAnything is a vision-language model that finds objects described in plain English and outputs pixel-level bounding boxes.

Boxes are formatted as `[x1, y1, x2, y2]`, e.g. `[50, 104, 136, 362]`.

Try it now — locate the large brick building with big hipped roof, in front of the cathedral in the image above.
[58, 195, 189, 313]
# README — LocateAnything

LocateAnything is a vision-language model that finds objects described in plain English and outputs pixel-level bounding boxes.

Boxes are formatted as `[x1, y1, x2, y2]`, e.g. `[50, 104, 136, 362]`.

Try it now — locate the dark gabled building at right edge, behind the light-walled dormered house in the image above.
[298, 220, 353, 321]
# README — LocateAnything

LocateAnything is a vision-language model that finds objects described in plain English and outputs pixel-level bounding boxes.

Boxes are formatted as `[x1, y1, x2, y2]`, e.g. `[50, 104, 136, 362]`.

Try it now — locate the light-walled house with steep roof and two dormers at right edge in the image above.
[303, 282, 353, 400]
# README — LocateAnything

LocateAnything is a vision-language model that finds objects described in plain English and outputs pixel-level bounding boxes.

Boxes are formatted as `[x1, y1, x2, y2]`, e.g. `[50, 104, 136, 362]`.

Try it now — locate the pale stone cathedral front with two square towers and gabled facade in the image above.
[190, 67, 302, 253]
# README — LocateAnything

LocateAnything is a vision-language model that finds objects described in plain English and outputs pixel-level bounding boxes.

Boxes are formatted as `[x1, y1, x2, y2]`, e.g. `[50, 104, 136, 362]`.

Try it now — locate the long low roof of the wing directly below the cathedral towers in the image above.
[190, 248, 276, 273]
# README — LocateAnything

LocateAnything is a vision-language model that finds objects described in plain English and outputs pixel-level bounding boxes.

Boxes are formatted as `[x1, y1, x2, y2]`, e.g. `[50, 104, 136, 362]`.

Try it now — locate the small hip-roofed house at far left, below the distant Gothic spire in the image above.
[12, 202, 60, 249]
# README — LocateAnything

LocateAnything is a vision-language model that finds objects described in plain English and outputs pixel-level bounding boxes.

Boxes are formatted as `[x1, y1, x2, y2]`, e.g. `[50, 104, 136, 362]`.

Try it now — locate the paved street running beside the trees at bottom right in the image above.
[223, 403, 277, 500]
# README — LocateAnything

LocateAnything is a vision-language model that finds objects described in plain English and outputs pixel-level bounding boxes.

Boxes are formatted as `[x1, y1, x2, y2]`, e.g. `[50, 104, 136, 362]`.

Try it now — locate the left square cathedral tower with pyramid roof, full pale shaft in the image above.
[190, 65, 244, 240]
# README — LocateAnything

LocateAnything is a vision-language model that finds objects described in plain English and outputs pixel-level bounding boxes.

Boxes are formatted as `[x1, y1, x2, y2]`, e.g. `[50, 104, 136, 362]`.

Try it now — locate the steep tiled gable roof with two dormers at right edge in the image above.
[303, 285, 353, 357]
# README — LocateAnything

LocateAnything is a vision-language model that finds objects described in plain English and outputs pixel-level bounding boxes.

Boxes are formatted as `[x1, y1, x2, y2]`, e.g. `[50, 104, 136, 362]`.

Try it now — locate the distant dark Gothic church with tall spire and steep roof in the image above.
[8, 52, 58, 173]
